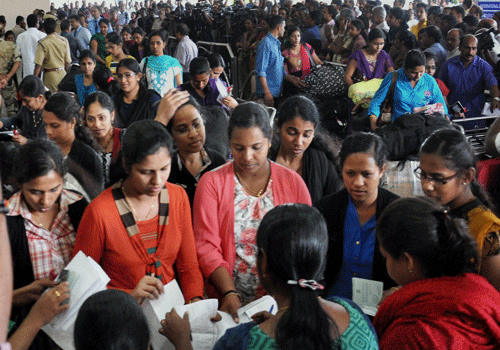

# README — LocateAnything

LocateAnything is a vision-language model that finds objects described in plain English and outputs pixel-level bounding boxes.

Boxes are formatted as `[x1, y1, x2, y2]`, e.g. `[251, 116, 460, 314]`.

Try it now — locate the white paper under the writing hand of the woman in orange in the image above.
[142, 280, 184, 350]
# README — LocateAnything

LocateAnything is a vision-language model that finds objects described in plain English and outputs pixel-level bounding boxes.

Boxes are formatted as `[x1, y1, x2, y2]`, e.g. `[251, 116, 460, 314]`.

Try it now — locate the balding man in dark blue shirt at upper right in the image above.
[439, 34, 500, 127]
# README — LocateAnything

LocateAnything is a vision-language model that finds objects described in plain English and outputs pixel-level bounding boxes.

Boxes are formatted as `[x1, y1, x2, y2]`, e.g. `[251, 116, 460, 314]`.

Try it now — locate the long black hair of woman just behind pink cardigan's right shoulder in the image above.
[269, 95, 339, 164]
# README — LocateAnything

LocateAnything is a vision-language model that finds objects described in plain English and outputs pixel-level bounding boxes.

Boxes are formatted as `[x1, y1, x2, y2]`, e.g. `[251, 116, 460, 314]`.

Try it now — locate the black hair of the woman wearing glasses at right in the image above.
[420, 129, 496, 211]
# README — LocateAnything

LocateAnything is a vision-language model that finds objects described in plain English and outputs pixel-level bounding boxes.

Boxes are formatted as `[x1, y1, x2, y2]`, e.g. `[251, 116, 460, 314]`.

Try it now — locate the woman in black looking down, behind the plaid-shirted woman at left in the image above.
[43, 92, 103, 199]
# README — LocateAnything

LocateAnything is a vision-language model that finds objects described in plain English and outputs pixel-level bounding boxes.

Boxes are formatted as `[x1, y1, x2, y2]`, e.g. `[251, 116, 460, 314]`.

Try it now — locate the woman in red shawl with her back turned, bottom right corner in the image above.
[374, 198, 500, 350]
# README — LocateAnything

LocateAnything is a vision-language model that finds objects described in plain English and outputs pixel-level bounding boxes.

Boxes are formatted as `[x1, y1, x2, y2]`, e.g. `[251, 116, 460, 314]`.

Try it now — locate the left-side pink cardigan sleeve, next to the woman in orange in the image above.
[193, 172, 232, 278]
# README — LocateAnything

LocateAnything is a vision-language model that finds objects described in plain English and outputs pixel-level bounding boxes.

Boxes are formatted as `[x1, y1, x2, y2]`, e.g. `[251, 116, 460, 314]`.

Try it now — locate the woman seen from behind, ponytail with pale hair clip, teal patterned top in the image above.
[164, 204, 378, 350]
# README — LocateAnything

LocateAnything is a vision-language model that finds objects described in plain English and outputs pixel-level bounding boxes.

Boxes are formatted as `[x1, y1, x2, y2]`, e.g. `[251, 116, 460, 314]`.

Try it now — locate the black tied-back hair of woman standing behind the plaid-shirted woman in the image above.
[44, 92, 99, 151]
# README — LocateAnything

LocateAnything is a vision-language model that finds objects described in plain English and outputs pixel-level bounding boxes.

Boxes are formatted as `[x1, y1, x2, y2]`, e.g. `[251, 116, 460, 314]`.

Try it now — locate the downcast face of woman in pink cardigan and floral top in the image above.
[229, 126, 271, 175]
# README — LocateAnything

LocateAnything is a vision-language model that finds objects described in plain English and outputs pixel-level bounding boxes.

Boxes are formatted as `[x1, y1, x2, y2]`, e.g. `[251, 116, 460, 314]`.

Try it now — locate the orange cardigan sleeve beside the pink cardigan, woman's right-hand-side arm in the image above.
[175, 188, 203, 303]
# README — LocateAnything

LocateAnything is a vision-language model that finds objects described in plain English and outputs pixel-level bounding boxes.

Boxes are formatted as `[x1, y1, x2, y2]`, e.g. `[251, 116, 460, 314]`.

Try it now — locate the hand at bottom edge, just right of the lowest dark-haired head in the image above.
[159, 309, 191, 349]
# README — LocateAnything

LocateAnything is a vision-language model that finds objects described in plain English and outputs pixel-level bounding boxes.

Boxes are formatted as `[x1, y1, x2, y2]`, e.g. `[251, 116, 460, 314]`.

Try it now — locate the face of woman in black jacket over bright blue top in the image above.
[342, 153, 385, 203]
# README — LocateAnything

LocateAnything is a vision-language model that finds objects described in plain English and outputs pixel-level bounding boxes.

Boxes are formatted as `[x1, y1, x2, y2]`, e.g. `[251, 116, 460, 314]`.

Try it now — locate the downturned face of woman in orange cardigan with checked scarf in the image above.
[127, 148, 172, 197]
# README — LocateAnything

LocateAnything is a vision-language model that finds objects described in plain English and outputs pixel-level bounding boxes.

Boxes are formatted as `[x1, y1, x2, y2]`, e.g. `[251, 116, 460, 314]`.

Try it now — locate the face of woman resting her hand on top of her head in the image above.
[172, 105, 205, 153]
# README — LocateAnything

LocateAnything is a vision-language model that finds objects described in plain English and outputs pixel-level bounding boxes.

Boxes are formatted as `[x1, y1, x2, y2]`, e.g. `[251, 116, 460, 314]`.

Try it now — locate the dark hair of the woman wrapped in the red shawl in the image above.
[377, 197, 479, 278]
